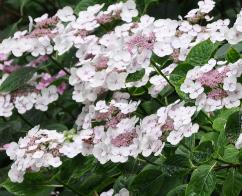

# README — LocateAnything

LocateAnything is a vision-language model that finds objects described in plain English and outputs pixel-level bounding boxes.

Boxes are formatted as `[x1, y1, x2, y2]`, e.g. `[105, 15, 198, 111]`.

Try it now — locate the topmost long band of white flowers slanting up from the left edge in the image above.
[0, 0, 138, 57]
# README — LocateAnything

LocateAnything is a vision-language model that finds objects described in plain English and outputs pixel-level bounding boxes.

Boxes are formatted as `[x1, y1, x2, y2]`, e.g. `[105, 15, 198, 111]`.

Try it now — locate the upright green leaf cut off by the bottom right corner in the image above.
[223, 168, 242, 196]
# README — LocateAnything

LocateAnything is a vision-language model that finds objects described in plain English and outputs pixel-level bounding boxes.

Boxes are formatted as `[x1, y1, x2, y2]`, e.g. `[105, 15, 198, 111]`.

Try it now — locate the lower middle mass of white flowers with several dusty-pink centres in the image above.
[61, 94, 199, 164]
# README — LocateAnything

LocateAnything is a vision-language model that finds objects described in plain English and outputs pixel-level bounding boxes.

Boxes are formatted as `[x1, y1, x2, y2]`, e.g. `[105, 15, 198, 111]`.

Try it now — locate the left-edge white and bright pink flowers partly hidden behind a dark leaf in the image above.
[0, 54, 64, 117]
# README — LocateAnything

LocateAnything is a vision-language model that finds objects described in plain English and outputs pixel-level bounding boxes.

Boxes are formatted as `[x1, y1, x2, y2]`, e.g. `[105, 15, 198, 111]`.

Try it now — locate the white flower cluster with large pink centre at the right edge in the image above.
[181, 59, 242, 112]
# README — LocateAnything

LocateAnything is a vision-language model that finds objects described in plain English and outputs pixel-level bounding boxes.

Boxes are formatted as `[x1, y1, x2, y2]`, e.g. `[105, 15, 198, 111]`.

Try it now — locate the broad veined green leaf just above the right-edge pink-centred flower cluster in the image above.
[186, 40, 219, 66]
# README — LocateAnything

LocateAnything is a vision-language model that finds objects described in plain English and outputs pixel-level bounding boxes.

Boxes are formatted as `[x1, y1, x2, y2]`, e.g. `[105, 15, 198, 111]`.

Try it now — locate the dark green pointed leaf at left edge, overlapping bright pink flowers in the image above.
[0, 67, 36, 92]
